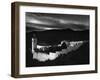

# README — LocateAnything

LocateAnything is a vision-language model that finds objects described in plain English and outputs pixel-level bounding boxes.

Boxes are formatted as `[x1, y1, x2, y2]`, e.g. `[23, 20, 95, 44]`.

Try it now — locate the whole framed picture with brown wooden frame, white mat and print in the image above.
[11, 2, 97, 78]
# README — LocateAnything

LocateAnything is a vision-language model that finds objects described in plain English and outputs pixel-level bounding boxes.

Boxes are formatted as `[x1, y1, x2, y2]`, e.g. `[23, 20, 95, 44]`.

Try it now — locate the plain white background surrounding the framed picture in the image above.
[0, 0, 100, 80]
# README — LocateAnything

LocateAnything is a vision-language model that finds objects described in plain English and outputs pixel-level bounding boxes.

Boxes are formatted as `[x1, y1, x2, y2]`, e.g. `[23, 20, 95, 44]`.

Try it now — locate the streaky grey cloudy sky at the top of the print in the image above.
[26, 12, 89, 30]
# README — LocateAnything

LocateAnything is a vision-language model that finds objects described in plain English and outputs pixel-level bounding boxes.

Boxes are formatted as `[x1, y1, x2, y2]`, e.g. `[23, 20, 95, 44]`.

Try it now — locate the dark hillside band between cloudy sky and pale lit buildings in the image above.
[27, 29, 89, 45]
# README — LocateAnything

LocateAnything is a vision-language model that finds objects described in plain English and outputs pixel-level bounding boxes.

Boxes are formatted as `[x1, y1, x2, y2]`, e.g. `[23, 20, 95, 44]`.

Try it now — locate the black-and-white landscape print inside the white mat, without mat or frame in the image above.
[25, 12, 90, 67]
